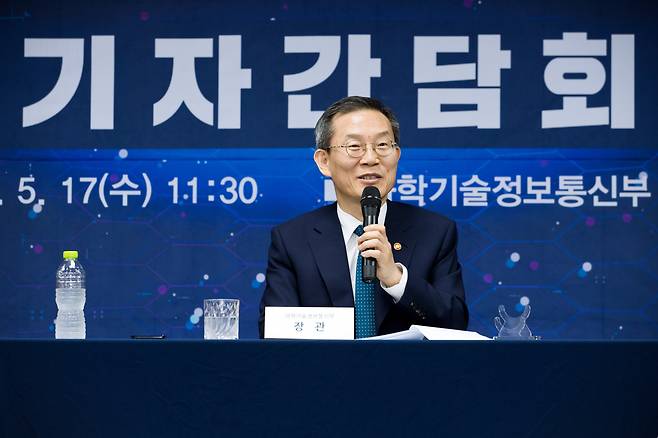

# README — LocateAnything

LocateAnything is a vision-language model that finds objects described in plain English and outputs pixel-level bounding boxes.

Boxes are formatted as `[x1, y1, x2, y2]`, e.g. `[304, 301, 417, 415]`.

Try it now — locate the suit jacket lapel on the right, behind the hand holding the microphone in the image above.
[375, 201, 416, 333]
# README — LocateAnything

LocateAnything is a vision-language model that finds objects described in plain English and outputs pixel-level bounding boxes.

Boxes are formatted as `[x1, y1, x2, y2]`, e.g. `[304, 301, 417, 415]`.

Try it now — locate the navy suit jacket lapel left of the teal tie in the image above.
[309, 204, 354, 307]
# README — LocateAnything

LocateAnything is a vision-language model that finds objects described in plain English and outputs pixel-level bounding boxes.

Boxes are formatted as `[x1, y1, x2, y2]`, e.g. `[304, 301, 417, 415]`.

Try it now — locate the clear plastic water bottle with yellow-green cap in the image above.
[55, 251, 87, 339]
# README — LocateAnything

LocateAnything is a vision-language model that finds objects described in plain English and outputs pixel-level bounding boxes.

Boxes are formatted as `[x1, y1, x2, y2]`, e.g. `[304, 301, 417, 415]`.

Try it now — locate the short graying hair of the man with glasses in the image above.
[315, 96, 400, 150]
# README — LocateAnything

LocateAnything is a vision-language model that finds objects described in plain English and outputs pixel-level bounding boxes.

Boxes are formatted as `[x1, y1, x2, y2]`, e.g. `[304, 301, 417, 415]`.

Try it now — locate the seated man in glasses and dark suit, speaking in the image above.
[259, 96, 468, 337]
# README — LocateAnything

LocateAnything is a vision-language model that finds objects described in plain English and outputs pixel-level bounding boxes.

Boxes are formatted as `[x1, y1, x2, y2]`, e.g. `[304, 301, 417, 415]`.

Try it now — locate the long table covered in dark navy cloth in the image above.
[0, 340, 658, 438]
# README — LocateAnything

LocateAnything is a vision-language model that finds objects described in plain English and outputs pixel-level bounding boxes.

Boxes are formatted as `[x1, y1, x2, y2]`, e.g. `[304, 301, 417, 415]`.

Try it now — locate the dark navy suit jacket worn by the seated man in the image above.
[258, 201, 468, 338]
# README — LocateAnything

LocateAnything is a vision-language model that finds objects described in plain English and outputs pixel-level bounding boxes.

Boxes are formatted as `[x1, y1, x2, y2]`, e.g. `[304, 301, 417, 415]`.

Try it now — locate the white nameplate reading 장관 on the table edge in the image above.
[265, 307, 354, 339]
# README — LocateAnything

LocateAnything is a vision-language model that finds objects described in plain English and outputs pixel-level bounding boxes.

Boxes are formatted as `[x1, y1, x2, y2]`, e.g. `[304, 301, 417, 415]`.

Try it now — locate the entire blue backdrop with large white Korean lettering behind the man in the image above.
[0, 0, 658, 339]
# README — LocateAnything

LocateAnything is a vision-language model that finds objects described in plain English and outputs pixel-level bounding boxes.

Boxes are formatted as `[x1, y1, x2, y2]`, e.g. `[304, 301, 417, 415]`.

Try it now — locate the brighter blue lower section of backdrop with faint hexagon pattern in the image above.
[0, 149, 658, 339]
